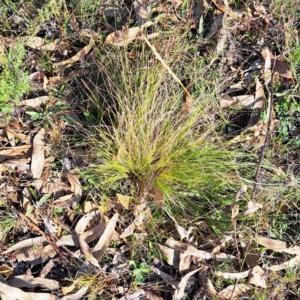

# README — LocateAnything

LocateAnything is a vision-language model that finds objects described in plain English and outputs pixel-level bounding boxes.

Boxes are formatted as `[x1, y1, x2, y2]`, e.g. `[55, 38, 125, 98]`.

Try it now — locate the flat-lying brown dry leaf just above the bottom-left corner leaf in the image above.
[7, 274, 60, 290]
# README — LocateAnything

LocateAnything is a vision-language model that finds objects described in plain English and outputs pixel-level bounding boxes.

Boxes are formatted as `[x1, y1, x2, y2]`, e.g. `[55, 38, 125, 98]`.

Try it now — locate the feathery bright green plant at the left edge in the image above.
[0, 43, 30, 122]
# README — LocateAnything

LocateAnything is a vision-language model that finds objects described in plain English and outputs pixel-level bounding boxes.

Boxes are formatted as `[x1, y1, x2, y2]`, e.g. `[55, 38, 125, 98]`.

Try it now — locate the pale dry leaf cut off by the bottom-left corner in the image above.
[0, 282, 57, 300]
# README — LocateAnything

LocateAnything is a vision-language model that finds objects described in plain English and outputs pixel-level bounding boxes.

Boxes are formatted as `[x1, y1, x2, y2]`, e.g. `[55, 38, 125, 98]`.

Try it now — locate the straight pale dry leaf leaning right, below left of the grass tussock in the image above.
[93, 213, 119, 260]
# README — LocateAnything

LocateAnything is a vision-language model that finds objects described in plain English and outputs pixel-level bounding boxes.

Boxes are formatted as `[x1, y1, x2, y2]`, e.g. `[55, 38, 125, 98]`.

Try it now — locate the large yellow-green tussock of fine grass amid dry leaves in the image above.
[85, 37, 241, 216]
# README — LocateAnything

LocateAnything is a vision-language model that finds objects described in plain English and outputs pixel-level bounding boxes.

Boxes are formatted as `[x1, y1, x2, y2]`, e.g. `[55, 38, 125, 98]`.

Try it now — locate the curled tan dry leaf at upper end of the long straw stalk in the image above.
[104, 21, 153, 47]
